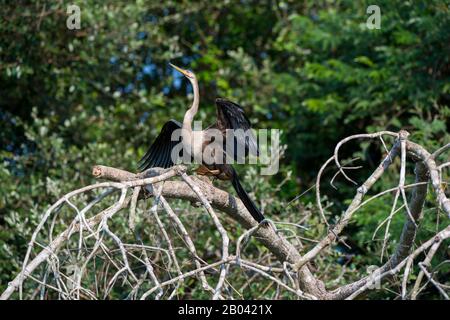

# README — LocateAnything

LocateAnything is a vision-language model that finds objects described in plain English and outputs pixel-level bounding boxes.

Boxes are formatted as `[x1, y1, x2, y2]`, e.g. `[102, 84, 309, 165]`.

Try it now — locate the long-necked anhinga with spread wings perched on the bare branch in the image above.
[140, 64, 264, 223]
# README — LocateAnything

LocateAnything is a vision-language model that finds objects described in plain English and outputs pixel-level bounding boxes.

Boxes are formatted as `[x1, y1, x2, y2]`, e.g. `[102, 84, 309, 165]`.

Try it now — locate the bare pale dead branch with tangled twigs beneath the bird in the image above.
[0, 131, 450, 300]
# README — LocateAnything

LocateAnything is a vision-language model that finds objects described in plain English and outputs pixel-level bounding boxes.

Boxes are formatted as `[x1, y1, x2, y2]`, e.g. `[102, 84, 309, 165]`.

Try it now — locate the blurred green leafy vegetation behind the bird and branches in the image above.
[0, 0, 450, 298]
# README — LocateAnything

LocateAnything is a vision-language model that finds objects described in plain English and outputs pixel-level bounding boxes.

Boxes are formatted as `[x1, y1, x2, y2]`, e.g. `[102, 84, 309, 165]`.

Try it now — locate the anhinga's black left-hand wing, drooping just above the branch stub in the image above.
[139, 119, 182, 171]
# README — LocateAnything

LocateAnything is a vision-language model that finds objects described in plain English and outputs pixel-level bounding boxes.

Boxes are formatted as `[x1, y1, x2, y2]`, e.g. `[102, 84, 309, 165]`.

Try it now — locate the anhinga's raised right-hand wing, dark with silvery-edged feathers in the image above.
[216, 98, 259, 160]
